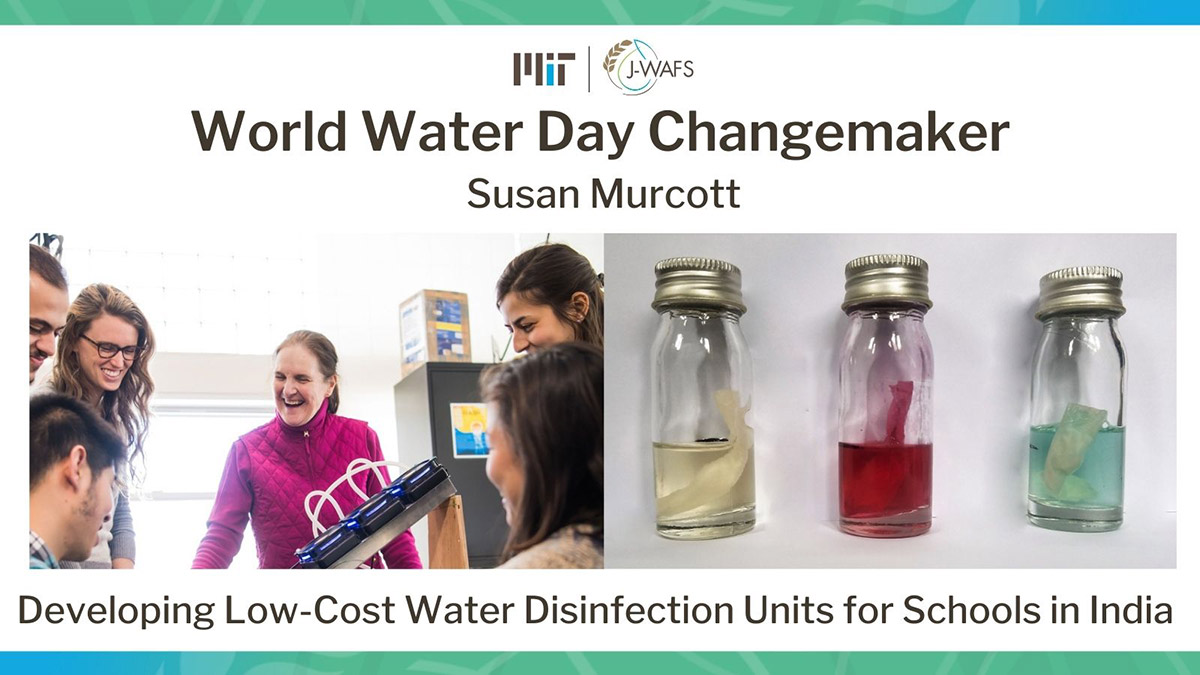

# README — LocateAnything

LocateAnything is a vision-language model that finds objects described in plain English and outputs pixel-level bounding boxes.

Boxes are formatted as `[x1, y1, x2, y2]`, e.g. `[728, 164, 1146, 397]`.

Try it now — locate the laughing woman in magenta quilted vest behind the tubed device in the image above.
[192, 330, 421, 568]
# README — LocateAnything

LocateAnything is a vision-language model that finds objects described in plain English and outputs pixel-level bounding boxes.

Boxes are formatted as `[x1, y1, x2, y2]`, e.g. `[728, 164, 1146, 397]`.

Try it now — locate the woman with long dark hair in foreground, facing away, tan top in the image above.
[480, 342, 604, 568]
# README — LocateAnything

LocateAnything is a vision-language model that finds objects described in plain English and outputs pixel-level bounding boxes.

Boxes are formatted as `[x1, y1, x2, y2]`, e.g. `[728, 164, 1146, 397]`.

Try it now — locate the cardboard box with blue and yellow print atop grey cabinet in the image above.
[400, 289, 470, 377]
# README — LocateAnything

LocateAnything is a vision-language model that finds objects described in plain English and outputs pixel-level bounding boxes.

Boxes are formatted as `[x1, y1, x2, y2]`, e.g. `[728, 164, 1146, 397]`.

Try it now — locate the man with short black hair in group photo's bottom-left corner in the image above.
[29, 394, 125, 569]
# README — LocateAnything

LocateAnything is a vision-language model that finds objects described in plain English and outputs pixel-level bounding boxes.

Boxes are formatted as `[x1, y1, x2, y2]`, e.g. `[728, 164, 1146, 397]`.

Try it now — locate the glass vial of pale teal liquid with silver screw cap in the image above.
[1028, 267, 1126, 532]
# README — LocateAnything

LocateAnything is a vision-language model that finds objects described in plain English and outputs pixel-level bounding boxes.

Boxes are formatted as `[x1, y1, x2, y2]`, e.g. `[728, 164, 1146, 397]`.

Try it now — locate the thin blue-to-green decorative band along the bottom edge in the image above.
[0, 648, 1200, 675]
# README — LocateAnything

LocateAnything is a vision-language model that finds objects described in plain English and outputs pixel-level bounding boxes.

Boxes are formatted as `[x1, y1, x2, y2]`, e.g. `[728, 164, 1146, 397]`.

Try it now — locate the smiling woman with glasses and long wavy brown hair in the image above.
[49, 283, 154, 568]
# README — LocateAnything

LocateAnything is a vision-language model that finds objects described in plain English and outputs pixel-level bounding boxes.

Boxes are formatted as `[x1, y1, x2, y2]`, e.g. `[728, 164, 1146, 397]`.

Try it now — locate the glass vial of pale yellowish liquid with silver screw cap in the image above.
[650, 257, 755, 539]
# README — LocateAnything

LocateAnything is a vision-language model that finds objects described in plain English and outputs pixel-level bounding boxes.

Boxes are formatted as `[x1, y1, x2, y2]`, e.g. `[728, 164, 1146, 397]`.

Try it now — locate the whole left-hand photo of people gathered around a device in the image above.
[29, 228, 605, 569]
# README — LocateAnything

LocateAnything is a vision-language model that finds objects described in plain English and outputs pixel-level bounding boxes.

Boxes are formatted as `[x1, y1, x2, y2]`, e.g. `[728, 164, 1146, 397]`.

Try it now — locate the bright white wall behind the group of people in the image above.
[71, 228, 604, 455]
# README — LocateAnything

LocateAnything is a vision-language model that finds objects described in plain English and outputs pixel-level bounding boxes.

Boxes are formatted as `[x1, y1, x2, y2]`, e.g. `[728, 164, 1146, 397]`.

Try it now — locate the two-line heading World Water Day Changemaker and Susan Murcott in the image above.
[192, 109, 1012, 209]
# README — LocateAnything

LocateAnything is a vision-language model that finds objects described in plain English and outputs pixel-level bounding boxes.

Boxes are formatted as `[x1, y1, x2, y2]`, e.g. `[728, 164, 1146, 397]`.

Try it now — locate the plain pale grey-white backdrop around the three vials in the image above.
[605, 234, 1176, 567]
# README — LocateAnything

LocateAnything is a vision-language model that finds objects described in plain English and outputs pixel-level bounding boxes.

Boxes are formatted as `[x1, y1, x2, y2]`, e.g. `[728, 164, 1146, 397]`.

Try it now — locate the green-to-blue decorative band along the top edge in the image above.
[0, 0, 1200, 25]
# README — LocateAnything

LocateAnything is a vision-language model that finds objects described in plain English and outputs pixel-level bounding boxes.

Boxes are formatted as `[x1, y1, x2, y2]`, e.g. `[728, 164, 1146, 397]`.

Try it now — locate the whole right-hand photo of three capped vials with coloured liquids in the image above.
[605, 234, 1177, 568]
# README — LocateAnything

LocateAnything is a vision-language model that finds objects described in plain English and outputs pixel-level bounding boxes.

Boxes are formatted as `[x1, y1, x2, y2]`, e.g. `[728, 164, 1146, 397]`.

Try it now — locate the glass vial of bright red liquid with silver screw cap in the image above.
[838, 255, 934, 537]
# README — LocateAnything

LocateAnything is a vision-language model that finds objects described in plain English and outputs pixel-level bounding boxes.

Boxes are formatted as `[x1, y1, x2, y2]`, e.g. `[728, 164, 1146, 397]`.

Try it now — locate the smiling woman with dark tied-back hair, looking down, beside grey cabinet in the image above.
[496, 244, 604, 352]
